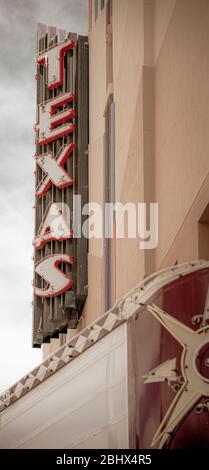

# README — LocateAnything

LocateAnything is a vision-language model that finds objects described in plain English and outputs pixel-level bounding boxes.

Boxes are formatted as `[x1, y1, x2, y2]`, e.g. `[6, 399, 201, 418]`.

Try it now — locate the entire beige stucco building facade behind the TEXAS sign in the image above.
[43, 0, 209, 356]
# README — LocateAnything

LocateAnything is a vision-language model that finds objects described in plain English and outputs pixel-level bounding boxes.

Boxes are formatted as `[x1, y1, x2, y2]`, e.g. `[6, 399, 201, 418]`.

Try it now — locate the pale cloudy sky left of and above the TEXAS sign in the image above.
[0, 0, 87, 392]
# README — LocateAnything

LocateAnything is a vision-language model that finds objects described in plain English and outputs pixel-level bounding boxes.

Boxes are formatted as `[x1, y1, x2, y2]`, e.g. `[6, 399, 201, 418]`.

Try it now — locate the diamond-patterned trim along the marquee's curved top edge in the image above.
[0, 261, 209, 412]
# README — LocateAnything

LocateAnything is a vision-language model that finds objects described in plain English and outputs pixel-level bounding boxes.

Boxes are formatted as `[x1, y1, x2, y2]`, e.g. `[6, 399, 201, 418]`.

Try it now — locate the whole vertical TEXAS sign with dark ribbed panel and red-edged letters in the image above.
[33, 25, 88, 347]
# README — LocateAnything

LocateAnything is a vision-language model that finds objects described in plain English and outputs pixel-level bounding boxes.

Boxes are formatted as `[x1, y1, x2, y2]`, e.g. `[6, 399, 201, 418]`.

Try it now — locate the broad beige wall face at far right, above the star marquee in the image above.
[155, 0, 209, 269]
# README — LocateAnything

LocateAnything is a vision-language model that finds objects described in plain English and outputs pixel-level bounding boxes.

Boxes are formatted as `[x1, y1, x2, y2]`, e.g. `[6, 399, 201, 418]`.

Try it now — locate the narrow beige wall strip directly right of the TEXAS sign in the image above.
[84, 10, 106, 324]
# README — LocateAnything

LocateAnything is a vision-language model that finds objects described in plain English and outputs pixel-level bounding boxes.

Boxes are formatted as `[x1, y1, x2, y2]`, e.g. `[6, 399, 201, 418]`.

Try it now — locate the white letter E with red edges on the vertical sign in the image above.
[36, 92, 75, 145]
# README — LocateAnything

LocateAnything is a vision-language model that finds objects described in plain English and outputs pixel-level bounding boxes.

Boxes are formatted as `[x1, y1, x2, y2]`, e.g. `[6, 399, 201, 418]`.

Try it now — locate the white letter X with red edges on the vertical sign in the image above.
[36, 144, 74, 197]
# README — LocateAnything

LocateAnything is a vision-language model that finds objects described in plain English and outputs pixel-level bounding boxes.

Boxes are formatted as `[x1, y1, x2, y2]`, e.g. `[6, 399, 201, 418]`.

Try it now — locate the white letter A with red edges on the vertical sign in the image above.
[33, 203, 73, 250]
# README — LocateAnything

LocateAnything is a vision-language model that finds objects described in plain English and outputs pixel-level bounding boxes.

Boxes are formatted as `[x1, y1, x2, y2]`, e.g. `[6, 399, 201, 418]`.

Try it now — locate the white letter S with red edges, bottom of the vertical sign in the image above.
[34, 254, 73, 298]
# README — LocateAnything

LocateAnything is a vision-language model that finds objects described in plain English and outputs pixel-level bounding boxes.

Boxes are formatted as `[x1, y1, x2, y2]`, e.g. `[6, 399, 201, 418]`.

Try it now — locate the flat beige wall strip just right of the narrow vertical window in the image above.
[113, 0, 144, 300]
